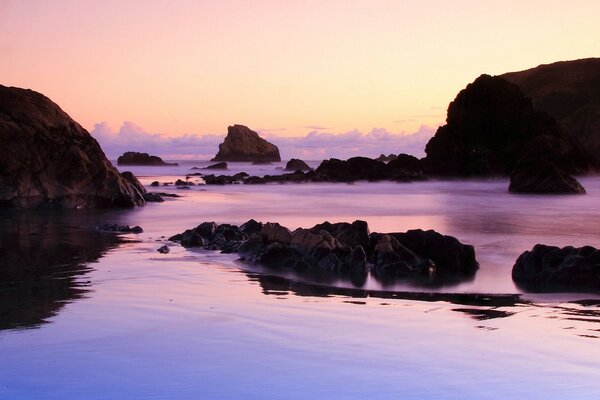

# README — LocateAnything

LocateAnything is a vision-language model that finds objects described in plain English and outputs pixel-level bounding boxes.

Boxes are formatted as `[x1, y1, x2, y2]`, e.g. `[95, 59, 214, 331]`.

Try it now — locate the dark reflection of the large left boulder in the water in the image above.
[0, 211, 120, 329]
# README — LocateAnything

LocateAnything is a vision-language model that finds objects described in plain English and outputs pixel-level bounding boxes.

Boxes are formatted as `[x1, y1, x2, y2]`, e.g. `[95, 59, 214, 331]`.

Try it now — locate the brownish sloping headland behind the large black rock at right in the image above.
[500, 58, 600, 154]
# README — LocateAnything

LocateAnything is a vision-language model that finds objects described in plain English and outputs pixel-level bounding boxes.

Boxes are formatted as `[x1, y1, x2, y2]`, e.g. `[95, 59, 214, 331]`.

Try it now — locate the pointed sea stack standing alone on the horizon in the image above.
[212, 125, 281, 162]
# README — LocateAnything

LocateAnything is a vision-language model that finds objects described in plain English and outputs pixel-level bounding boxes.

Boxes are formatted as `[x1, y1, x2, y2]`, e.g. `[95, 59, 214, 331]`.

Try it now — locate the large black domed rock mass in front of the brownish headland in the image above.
[423, 75, 598, 176]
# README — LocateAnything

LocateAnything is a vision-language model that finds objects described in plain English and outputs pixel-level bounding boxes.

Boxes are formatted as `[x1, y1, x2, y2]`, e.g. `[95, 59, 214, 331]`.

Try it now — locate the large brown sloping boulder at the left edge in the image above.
[0, 85, 145, 208]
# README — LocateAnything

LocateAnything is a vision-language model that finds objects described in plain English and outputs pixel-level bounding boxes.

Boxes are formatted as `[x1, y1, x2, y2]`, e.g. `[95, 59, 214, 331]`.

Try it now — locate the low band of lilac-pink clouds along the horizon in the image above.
[91, 122, 436, 160]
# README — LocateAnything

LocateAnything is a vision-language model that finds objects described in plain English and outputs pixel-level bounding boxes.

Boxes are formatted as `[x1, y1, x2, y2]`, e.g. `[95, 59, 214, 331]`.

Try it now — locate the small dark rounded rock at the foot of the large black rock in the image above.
[508, 159, 585, 194]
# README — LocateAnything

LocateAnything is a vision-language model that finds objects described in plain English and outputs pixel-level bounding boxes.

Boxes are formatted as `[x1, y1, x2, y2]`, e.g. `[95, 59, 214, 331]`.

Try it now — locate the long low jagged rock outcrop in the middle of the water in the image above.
[170, 220, 478, 279]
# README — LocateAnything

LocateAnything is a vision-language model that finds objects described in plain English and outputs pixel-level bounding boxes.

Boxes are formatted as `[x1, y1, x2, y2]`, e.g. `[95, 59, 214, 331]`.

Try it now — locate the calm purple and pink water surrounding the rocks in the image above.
[0, 164, 600, 399]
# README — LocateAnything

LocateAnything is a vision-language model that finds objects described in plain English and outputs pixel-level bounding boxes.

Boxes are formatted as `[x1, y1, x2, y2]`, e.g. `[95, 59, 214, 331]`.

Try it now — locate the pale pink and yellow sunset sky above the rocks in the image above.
[0, 0, 600, 157]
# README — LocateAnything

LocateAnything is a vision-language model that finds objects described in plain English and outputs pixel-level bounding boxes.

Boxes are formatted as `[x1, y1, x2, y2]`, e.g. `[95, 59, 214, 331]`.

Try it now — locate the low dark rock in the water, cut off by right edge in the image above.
[512, 244, 600, 290]
